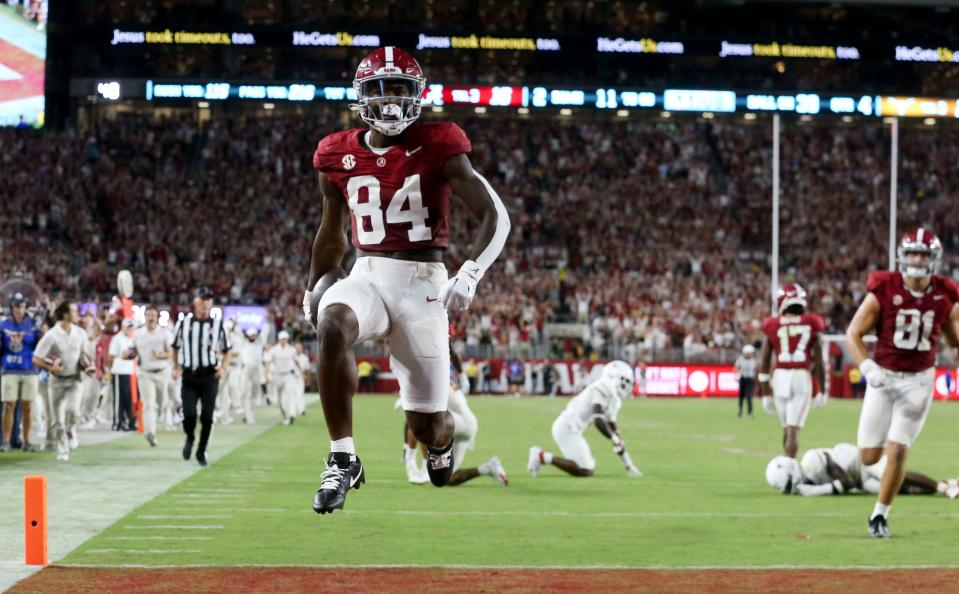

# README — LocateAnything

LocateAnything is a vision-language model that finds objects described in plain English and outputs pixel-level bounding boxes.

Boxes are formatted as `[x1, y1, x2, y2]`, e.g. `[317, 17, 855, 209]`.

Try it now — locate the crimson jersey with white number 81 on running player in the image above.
[866, 270, 959, 372]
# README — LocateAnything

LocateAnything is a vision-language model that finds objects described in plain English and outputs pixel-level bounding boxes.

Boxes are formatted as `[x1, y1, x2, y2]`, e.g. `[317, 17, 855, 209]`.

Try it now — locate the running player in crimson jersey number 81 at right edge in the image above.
[846, 228, 959, 538]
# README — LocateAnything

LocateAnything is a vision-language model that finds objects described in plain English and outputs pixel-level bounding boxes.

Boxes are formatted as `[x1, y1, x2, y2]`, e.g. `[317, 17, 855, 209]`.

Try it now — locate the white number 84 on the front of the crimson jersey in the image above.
[346, 173, 433, 245]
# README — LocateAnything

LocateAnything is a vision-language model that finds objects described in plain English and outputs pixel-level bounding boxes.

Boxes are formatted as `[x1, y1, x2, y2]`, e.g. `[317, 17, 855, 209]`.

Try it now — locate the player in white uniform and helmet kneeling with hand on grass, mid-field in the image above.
[526, 361, 643, 477]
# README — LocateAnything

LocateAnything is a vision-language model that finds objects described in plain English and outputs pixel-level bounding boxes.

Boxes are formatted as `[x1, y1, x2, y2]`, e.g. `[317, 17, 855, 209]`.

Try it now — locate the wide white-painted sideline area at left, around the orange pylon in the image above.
[0, 400, 279, 592]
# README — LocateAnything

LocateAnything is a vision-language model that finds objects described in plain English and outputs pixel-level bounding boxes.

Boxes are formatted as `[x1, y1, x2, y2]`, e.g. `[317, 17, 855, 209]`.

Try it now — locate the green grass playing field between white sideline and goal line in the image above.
[61, 390, 959, 567]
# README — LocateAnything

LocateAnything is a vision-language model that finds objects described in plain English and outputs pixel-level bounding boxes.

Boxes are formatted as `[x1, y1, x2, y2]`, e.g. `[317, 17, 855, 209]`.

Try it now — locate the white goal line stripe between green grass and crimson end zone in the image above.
[54, 551, 959, 571]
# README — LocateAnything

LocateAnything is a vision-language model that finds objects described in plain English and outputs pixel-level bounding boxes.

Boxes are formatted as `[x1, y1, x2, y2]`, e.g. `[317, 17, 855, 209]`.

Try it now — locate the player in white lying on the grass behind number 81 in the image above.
[766, 443, 959, 499]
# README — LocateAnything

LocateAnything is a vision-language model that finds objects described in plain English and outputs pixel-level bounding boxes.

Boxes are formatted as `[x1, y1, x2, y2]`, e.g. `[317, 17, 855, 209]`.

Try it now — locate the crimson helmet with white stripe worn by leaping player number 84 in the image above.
[350, 45, 426, 136]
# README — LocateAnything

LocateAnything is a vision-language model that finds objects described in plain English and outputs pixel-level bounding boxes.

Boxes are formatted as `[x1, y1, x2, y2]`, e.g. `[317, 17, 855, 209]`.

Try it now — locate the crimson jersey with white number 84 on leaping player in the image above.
[313, 122, 472, 252]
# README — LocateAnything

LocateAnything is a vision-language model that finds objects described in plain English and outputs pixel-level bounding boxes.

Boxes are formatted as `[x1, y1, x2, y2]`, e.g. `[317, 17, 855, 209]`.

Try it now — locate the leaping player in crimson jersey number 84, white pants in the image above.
[303, 46, 510, 513]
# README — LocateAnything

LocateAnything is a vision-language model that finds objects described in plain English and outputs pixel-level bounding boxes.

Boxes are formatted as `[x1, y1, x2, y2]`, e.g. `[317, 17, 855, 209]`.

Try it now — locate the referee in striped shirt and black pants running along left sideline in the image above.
[173, 287, 233, 466]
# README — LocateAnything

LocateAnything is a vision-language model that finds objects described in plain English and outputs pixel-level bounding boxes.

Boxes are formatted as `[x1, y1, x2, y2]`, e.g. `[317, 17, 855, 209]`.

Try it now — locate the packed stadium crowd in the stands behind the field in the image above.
[0, 109, 959, 360]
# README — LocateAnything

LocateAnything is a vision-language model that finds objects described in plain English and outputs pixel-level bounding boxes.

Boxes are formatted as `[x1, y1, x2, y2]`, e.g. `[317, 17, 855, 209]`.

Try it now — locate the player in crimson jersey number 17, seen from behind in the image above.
[757, 283, 827, 458]
